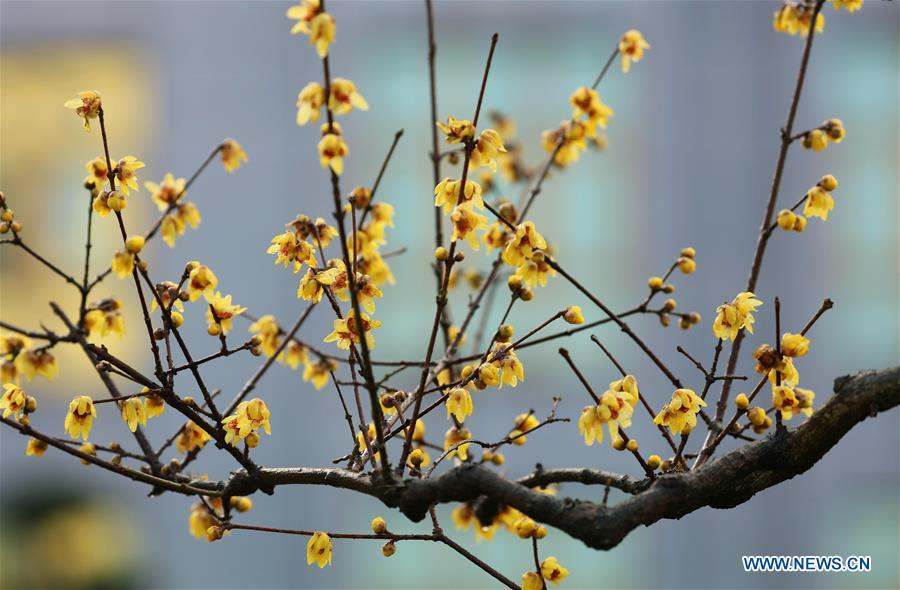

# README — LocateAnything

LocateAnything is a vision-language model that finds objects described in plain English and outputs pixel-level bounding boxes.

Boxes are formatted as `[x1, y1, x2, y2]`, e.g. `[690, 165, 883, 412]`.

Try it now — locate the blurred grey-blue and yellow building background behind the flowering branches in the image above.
[0, 0, 900, 588]
